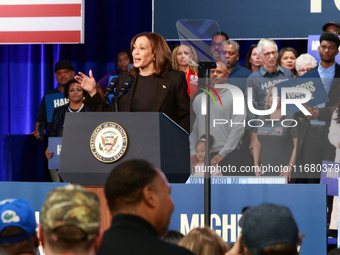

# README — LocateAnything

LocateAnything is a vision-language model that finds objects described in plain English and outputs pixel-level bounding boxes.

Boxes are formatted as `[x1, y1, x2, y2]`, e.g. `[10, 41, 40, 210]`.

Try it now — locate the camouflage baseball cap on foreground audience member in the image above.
[41, 184, 100, 240]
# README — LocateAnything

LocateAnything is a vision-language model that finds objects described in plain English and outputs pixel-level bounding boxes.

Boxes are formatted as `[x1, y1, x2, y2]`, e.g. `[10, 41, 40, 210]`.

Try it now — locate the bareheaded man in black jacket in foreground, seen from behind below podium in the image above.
[97, 160, 192, 255]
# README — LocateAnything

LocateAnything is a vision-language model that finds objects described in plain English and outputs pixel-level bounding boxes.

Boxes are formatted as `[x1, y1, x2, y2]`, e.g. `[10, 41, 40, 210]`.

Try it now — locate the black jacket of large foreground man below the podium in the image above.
[97, 214, 193, 255]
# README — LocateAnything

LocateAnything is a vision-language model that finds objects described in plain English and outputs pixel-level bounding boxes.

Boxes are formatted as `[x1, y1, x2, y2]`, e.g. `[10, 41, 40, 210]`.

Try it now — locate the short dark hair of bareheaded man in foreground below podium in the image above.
[104, 159, 157, 212]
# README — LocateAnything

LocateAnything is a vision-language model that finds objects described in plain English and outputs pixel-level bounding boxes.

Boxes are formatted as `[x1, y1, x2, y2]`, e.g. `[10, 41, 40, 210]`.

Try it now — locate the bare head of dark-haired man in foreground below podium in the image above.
[105, 160, 174, 236]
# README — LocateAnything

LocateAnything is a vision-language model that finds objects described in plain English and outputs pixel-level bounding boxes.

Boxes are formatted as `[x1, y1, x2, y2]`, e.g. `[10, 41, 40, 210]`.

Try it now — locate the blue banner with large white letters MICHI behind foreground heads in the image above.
[169, 184, 327, 255]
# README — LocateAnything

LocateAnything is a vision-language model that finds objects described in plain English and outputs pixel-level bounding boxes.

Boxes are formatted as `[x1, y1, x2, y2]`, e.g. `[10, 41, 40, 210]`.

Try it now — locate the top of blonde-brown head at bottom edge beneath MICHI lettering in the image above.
[178, 227, 230, 255]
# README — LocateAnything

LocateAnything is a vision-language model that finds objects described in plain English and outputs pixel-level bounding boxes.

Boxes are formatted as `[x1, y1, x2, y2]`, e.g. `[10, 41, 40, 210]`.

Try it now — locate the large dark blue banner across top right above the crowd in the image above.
[153, 0, 340, 39]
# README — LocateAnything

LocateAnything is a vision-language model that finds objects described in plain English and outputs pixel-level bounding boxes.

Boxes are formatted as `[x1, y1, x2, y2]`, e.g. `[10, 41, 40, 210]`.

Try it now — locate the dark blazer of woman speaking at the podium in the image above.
[84, 70, 190, 132]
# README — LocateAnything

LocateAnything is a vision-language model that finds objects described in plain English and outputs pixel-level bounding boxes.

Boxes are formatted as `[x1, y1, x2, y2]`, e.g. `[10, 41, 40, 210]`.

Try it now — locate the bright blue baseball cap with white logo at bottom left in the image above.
[0, 198, 37, 244]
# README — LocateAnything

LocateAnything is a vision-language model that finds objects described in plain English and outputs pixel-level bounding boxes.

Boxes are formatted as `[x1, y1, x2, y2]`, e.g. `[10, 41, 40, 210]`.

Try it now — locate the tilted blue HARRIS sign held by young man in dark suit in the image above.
[275, 71, 329, 114]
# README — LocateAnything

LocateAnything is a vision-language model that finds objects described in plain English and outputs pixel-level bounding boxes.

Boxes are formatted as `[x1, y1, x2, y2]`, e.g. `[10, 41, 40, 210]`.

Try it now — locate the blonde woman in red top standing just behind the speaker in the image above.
[171, 44, 198, 99]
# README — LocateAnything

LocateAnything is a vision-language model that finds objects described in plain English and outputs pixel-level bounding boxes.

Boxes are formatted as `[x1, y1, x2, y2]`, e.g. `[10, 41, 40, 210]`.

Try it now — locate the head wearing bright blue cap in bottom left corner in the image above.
[0, 198, 39, 255]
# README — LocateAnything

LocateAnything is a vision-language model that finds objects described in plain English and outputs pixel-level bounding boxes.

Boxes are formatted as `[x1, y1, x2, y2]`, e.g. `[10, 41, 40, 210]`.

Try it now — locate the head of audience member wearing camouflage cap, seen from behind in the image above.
[39, 184, 102, 255]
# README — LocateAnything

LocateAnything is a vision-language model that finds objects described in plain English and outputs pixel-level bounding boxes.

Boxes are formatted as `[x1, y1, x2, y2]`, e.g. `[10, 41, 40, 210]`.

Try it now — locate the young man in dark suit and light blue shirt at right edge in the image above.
[297, 32, 340, 183]
